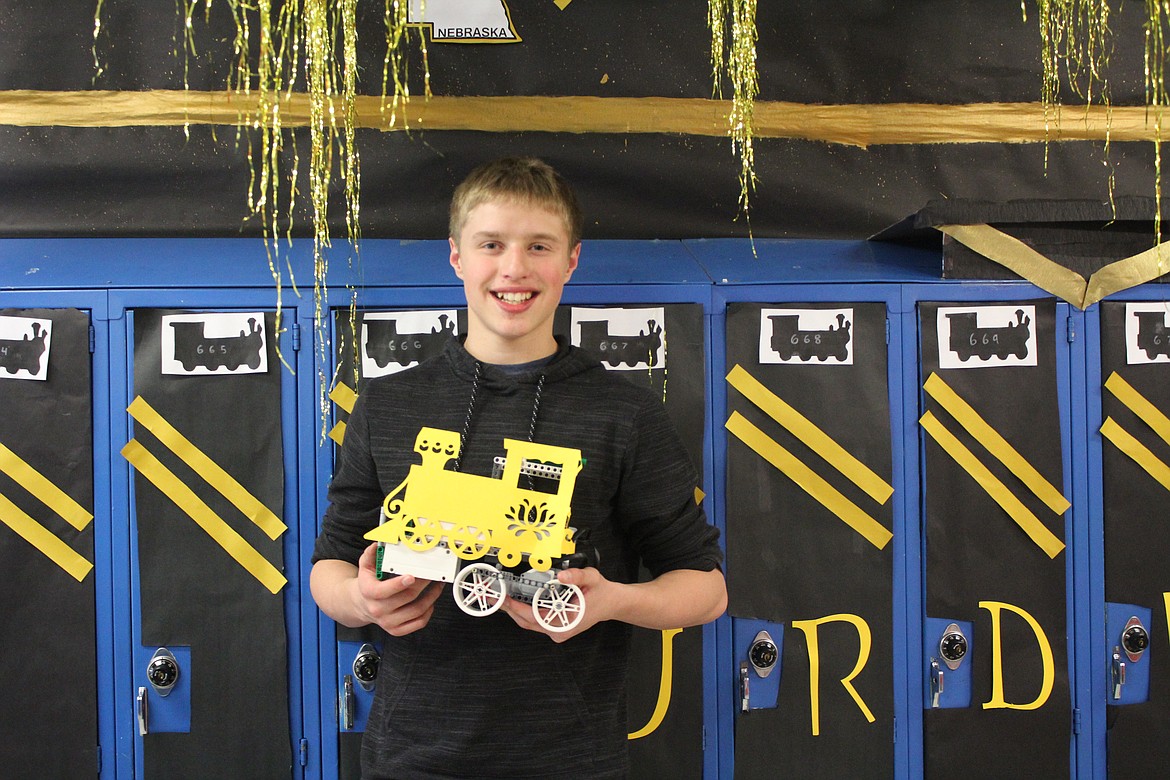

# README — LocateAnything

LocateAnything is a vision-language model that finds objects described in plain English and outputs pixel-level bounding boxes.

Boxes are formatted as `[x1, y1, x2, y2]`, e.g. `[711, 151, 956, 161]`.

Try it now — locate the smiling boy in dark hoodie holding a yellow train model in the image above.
[310, 158, 727, 780]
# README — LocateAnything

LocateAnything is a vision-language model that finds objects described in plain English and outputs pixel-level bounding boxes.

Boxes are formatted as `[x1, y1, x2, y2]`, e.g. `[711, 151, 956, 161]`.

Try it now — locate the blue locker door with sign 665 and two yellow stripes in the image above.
[113, 301, 303, 778]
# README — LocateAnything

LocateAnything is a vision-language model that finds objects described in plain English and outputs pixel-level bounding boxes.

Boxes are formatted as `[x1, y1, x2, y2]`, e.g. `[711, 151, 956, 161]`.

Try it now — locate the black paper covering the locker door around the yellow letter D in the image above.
[918, 301, 1072, 778]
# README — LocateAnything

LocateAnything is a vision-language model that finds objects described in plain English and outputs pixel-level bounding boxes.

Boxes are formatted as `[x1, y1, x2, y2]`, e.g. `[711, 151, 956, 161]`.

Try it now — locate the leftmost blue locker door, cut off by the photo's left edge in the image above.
[0, 292, 116, 778]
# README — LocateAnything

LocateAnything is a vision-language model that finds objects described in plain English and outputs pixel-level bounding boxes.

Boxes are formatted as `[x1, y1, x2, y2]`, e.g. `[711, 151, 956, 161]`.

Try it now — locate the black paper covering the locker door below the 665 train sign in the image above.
[133, 310, 293, 780]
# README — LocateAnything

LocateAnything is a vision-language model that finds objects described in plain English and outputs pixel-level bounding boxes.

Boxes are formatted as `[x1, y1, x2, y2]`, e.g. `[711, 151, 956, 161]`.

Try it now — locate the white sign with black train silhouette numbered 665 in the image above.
[161, 311, 268, 377]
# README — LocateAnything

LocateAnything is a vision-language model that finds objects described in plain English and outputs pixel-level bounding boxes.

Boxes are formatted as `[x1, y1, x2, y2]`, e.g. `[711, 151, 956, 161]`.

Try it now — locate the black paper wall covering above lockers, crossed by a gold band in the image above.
[0, 0, 1155, 239]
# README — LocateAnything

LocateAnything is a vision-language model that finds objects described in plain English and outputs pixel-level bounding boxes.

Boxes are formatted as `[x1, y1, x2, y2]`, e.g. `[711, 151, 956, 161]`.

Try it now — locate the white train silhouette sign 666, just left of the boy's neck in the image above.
[360, 309, 457, 378]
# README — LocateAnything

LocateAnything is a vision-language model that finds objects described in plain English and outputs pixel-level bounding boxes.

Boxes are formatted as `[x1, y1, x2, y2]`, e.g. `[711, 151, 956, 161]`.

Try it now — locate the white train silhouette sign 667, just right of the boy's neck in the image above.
[569, 306, 667, 371]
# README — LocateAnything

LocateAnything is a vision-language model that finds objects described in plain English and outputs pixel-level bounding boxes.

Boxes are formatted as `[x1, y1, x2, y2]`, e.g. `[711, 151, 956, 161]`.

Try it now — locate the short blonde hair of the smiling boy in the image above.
[447, 157, 585, 247]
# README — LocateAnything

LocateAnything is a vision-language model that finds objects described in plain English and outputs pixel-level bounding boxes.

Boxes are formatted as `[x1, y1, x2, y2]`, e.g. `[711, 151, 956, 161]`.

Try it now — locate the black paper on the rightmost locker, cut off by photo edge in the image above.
[1092, 302, 1170, 778]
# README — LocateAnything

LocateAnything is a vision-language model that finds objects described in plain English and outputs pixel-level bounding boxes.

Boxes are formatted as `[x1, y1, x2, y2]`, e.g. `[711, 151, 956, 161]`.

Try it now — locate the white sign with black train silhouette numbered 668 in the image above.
[759, 309, 853, 366]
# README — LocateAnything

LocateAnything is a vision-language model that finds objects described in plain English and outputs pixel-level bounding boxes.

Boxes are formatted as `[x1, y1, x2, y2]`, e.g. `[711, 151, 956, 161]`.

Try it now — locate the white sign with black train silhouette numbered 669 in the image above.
[937, 304, 1037, 368]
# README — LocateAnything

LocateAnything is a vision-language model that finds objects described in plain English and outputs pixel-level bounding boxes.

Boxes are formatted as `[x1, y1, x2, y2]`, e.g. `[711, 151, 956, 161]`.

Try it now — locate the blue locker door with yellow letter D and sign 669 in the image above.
[911, 295, 1075, 778]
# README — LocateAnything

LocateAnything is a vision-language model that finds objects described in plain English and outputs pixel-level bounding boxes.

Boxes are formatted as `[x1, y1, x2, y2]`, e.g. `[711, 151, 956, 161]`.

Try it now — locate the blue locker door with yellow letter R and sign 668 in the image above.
[716, 292, 904, 779]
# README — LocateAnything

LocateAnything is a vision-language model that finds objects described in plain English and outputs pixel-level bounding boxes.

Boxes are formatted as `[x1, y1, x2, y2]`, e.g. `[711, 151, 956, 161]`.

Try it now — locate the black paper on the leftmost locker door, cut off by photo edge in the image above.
[0, 309, 101, 780]
